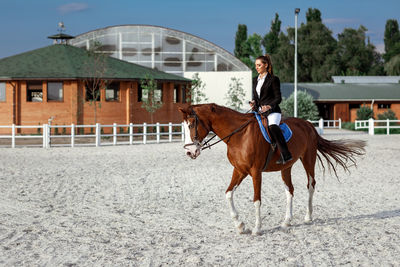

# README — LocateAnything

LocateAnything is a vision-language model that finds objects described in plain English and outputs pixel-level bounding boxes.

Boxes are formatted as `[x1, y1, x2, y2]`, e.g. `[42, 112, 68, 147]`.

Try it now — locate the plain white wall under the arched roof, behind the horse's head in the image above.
[183, 71, 252, 109]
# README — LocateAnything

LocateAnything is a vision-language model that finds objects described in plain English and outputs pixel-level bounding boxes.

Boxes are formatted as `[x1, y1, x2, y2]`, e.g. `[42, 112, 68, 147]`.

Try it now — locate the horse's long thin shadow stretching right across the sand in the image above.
[262, 209, 400, 234]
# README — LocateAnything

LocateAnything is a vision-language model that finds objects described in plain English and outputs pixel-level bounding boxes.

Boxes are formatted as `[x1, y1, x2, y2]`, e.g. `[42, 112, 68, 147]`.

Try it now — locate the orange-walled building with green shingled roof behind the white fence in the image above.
[0, 42, 191, 133]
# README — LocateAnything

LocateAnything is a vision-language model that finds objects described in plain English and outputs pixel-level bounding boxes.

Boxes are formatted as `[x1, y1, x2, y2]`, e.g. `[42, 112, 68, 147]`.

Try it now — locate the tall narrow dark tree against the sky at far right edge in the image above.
[383, 19, 400, 62]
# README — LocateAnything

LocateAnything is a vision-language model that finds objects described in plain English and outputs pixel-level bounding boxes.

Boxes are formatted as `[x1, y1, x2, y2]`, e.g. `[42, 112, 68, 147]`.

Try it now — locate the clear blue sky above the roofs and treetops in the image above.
[0, 0, 400, 58]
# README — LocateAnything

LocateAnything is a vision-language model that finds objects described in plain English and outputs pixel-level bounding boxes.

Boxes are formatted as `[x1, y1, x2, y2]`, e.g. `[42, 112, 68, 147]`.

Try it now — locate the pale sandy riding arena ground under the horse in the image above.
[0, 129, 400, 266]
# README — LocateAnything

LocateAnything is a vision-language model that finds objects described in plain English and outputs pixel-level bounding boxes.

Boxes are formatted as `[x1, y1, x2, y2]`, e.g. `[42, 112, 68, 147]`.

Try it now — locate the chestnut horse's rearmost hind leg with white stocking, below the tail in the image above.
[301, 151, 317, 223]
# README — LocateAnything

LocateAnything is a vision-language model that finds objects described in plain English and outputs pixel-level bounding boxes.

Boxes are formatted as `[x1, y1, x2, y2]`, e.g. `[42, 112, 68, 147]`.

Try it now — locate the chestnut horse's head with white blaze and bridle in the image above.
[179, 106, 210, 159]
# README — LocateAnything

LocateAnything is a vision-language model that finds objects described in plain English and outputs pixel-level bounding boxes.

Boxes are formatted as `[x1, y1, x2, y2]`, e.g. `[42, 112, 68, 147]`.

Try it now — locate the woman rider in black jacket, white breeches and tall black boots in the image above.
[250, 54, 292, 164]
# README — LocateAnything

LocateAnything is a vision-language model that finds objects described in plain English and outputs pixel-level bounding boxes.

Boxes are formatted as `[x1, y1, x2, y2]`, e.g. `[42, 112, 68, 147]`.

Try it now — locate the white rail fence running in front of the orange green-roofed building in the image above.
[0, 123, 185, 148]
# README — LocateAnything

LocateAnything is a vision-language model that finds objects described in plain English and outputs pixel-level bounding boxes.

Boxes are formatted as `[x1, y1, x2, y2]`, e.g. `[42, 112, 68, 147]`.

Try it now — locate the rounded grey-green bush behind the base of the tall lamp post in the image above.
[280, 91, 319, 120]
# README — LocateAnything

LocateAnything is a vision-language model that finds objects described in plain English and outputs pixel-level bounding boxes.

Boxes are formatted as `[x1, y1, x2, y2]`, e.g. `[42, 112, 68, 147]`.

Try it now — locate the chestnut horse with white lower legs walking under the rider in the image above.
[179, 104, 365, 235]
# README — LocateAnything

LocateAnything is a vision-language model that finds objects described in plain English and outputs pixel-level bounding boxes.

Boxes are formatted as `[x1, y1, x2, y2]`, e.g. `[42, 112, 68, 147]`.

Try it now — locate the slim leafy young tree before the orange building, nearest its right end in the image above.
[140, 75, 163, 123]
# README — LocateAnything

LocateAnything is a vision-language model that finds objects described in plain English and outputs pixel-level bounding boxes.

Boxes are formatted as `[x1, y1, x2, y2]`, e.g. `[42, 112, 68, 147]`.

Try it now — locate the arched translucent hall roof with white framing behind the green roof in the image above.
[68, 25, 251, 75]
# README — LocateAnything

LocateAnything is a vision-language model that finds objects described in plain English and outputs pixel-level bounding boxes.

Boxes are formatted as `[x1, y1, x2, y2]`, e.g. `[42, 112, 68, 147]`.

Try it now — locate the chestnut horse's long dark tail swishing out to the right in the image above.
[313, 127, 366, 177]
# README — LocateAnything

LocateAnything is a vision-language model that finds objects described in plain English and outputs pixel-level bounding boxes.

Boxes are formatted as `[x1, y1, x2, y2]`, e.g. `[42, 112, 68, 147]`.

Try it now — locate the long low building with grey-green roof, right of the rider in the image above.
[281, 76, 400, 122]
